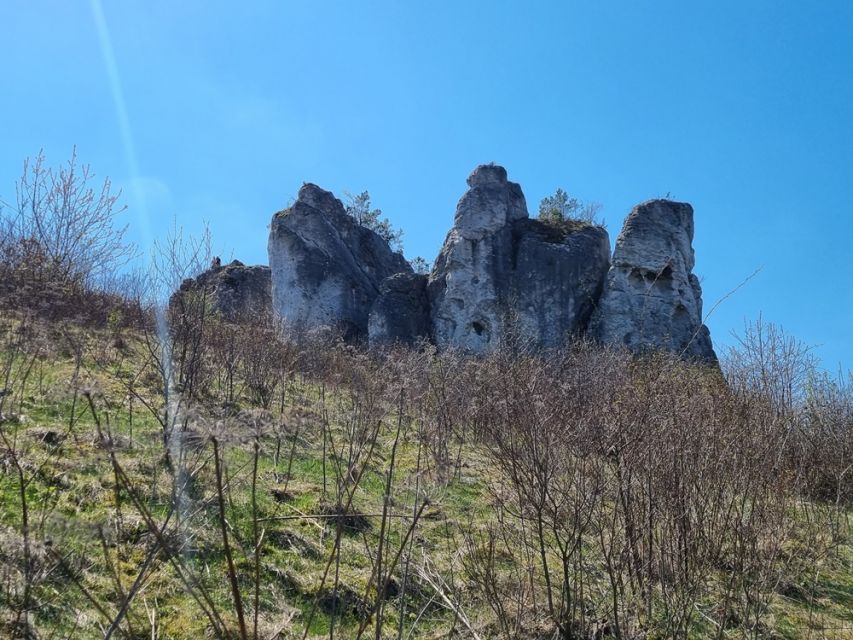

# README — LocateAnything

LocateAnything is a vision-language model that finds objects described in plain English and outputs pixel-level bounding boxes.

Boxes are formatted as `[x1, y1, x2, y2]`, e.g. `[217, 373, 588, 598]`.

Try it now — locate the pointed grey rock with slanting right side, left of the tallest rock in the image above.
[268, 184, 411, 339]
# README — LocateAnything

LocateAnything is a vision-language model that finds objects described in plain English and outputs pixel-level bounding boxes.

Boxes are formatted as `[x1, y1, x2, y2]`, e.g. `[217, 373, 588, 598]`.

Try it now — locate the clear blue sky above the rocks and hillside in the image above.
[0, 0, 853, 369]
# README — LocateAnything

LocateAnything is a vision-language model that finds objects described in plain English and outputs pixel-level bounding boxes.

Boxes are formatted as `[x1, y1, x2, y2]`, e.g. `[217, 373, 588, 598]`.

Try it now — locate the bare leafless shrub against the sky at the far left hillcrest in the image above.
[0, 149, 138, 325]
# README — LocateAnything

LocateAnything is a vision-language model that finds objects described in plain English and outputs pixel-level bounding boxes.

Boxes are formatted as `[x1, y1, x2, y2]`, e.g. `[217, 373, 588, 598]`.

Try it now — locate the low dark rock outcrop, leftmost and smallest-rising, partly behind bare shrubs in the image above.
[175, 260, 272, 322]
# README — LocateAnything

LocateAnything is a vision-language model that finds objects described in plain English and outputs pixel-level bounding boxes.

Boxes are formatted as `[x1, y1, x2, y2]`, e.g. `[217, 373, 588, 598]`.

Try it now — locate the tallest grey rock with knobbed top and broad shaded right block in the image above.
[428, 165, 610, 353]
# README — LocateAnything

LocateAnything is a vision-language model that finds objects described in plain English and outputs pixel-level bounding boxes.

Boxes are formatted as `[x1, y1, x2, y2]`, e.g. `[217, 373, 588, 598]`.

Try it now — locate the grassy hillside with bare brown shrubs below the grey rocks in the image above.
[0, 313, 853, 639]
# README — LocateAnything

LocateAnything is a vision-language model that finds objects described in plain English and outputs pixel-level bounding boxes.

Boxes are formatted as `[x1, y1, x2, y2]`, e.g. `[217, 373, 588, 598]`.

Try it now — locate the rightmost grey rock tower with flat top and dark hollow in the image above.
[591, 200, 716, 361]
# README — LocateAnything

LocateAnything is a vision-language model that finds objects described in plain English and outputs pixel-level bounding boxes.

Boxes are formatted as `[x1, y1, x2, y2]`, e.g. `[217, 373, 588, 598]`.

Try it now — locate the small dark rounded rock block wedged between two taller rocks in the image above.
[367, 273, 430, 346]
